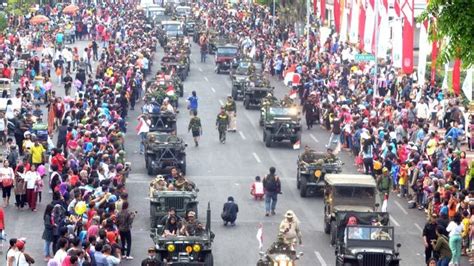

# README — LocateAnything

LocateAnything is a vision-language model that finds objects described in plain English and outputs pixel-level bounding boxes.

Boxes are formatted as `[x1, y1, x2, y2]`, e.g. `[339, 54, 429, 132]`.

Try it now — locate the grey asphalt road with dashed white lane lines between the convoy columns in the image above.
[0, 39, 438, 266]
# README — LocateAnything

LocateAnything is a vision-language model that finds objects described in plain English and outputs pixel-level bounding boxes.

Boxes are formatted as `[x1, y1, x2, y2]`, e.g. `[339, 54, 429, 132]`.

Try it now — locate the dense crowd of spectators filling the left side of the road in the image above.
[0, 3, 161, 266]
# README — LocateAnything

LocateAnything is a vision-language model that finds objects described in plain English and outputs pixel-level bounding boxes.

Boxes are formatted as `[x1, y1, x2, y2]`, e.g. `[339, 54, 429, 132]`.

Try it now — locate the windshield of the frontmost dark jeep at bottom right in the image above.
[345, 226, 393, 241]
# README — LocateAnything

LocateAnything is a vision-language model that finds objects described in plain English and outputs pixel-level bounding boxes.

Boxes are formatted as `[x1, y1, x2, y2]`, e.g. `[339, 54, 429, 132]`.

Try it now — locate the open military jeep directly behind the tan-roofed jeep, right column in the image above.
[296, 150, 343, 198]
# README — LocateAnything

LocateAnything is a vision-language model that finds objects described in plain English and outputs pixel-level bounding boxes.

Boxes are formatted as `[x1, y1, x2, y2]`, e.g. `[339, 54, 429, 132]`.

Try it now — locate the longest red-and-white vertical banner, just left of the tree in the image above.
[400, 0, 415, 74]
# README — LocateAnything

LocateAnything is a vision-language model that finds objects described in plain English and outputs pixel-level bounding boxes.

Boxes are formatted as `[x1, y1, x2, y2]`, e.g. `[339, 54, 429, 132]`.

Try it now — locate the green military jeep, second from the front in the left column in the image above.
[150, 190, 199, 231]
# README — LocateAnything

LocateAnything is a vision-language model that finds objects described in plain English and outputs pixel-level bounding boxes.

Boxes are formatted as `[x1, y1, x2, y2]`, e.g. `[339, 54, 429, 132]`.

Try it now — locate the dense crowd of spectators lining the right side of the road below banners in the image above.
[196, 3, 474, 265]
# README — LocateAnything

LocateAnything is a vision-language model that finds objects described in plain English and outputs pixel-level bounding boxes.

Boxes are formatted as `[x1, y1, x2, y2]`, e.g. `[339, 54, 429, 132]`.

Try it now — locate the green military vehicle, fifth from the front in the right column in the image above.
[244, 75, 274, 110]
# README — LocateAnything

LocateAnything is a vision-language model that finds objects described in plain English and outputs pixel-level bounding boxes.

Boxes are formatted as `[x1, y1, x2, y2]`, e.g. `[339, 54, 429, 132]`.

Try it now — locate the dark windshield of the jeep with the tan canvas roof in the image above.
[333, 186, 375, 207]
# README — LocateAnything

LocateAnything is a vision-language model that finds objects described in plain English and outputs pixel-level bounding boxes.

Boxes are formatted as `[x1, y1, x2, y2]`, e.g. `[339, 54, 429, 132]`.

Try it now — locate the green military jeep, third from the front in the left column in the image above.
[144, 132, 187, 175]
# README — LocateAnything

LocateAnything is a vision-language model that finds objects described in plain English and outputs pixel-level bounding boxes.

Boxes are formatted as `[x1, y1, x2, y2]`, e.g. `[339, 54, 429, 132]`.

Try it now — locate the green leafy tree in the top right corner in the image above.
[417, 0, 474, 68]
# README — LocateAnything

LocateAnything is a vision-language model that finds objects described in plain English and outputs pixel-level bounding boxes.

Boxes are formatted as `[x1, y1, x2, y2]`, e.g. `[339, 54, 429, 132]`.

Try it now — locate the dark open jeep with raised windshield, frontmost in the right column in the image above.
[335, 211, 401, 266]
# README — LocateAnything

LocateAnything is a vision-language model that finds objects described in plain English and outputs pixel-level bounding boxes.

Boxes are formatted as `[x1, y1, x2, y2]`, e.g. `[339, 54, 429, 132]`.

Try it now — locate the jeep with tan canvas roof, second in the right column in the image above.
[324, 174, 378, 245]
